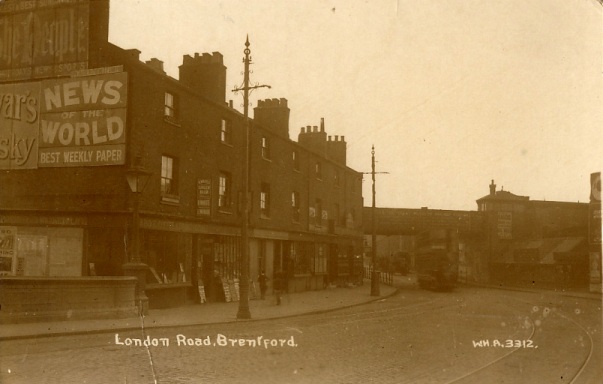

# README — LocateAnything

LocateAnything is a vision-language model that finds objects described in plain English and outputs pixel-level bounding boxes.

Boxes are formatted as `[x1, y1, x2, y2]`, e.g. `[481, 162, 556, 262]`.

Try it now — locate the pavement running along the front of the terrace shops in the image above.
[0, 281, 397, 341]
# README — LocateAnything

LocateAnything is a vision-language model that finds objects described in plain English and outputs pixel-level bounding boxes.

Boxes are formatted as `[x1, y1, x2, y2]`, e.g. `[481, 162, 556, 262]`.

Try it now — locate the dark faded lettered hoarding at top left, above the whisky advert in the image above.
[0, 0, 90, 81]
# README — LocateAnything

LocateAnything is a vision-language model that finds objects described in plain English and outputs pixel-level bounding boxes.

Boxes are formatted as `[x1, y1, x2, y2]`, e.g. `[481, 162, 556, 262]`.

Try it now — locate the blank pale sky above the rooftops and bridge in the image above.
[109, 0, 603, 210]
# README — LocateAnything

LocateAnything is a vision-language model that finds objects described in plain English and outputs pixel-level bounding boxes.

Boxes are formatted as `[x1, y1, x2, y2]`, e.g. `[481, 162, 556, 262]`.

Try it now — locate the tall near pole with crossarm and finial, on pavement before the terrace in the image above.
[232, 36, 270, 319]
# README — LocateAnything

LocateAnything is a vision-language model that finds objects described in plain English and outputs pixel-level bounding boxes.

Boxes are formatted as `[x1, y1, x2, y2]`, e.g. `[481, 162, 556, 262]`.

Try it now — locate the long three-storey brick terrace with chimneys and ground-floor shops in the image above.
[0, 0, 362, 307]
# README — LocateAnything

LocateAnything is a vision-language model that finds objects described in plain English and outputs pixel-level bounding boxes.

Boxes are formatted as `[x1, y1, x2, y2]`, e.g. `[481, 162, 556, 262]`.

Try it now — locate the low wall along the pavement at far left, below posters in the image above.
[0, 277, 138, 323]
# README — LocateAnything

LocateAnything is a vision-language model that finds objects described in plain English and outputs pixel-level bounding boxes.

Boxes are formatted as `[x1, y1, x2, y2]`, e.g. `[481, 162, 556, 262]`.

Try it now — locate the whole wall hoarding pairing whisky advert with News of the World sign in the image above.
[0, 72, 127, 169]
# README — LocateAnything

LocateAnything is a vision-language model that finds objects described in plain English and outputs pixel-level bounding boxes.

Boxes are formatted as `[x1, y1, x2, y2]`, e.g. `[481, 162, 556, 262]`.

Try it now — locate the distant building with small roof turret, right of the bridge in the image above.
[477, 181, 588, 287]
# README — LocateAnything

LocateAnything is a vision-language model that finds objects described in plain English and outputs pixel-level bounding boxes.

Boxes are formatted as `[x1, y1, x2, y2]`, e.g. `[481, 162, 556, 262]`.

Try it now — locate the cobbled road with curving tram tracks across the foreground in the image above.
[0, 287, 603, 384]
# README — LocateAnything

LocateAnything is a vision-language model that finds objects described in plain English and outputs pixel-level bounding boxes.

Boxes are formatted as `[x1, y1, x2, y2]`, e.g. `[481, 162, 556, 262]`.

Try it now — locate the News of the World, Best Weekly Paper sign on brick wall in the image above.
[38, 73, 127, 167]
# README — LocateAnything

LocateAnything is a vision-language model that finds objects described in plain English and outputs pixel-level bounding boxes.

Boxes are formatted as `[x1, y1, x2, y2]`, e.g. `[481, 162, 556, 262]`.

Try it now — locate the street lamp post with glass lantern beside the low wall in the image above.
[122, 158, 151, 315]
